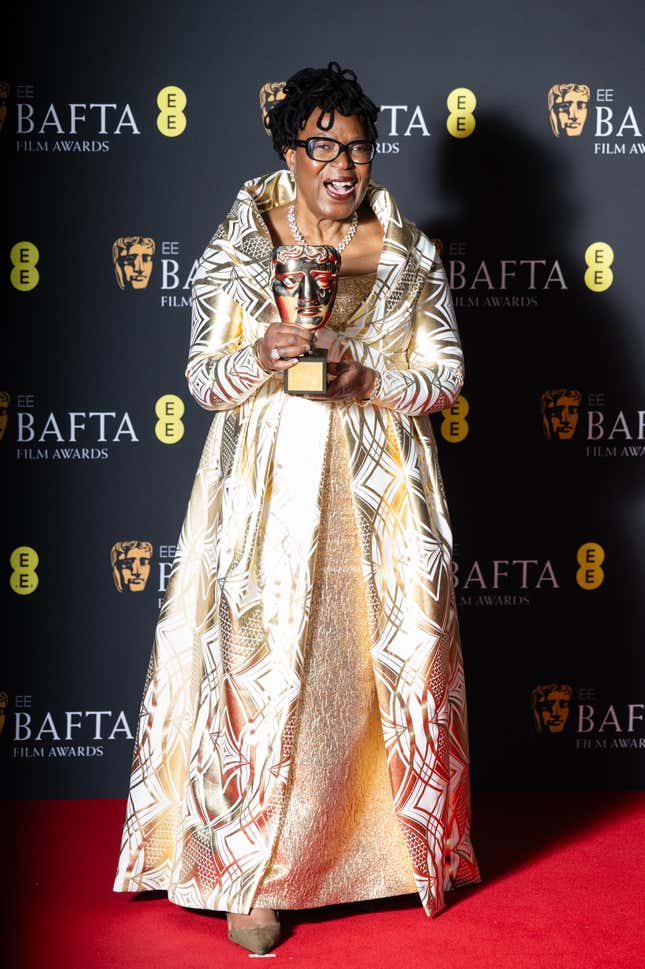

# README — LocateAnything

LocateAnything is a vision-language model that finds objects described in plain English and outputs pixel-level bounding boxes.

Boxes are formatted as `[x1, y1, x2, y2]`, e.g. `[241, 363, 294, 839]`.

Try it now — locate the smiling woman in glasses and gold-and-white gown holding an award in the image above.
[114, 63, 479, 952]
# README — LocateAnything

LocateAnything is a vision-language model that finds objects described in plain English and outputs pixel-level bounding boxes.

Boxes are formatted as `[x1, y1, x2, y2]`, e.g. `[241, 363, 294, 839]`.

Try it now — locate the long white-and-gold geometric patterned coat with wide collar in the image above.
[114, 171, 479, 915]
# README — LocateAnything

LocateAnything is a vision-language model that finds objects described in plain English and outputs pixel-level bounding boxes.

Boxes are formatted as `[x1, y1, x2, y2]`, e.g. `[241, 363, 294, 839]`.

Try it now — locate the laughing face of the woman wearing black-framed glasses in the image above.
[284, 109, 372, 221]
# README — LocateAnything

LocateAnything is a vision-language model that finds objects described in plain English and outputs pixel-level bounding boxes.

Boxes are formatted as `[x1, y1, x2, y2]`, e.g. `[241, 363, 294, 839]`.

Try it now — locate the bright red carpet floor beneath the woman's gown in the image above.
[2, 793, 645, 969]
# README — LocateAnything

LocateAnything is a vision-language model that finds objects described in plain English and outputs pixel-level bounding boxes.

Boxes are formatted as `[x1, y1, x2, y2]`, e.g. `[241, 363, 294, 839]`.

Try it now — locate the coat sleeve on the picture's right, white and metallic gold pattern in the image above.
[342, 257, 464, 417]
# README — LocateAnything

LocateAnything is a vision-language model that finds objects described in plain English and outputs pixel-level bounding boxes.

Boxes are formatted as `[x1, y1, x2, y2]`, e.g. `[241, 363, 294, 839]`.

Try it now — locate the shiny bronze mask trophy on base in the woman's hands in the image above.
[272, 243, 340, 394]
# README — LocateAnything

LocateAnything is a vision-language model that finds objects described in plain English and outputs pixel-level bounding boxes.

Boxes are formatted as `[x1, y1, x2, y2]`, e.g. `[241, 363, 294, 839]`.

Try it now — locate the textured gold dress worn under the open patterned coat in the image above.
[255, 274, 417, 909]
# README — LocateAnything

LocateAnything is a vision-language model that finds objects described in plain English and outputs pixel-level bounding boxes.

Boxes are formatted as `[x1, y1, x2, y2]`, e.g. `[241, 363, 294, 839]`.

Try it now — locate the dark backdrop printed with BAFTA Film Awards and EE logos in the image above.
[0, 0, 645, 797]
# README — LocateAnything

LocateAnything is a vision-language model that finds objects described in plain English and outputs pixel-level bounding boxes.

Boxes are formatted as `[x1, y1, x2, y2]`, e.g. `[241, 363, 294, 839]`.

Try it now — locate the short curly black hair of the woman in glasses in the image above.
[266, 61, 379, 158]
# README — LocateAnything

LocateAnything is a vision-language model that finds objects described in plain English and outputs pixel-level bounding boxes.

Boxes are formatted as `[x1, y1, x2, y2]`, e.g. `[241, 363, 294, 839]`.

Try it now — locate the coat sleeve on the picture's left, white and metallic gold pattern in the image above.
[185, 278, 271, 410]
